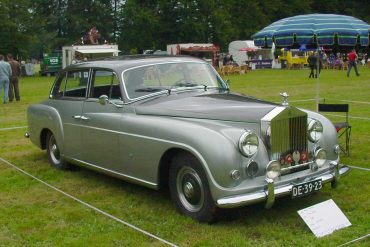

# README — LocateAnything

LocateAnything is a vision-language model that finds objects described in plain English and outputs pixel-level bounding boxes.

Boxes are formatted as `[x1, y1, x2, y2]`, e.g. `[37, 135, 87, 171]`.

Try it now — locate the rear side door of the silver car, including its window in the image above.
[50, 68, 90, 159]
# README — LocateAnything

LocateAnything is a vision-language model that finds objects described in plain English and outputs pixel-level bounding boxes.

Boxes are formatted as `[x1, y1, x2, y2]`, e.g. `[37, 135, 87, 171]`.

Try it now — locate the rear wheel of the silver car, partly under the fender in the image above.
[46, 132, 68, 170]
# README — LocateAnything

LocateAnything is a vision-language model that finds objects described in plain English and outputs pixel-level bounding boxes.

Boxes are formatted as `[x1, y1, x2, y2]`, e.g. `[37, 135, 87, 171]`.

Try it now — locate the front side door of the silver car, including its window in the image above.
[81, 69, 123, 171]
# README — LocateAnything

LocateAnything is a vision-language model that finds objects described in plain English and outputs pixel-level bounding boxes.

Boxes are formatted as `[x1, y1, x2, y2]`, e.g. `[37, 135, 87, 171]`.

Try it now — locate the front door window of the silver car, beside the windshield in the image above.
[89, 70, 122, 99]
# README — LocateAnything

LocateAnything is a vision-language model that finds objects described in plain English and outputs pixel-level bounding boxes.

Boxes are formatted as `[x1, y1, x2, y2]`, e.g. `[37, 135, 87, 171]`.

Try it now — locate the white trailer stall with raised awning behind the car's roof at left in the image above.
[62, 44, 120, 69]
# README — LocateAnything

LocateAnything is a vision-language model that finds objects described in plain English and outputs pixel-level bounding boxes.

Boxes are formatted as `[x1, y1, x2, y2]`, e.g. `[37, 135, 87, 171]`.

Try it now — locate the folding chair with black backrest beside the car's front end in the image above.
[319, 104, 352, 156]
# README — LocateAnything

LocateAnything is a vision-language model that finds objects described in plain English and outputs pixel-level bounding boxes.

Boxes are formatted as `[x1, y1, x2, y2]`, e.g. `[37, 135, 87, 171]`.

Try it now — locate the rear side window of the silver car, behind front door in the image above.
[52, 69, 89, 98]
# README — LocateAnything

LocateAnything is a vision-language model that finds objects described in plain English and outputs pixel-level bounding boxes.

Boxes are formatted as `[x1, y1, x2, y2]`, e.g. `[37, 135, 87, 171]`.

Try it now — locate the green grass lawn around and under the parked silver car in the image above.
[0, 68, 370, 246]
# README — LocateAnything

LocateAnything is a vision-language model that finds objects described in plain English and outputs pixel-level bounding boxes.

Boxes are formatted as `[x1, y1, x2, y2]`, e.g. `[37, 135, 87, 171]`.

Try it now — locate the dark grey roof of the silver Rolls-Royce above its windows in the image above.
[66, 55, 206, 71]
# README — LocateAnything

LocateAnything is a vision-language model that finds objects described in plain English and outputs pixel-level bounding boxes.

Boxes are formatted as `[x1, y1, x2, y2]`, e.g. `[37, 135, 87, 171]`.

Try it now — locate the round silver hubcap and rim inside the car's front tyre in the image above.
[176, 167, 204, 212]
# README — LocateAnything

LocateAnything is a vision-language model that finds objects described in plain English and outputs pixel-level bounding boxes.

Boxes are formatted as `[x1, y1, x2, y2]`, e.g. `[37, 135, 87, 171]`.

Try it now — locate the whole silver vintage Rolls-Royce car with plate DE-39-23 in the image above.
[26, 56, 349, 222]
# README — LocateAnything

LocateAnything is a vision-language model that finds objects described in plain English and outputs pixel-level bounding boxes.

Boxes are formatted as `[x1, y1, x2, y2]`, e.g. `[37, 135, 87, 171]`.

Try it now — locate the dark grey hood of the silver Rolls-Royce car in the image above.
[135, 92, 277, 122]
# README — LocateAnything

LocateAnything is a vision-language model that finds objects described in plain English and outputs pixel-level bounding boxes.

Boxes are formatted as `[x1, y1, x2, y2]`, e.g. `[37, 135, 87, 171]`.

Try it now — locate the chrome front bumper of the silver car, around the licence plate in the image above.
[216, 162, 350, 208]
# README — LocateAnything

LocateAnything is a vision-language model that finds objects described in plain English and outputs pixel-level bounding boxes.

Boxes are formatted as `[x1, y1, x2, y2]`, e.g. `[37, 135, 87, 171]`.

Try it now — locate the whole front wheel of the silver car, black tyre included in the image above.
[169, 154, 217, 223]
